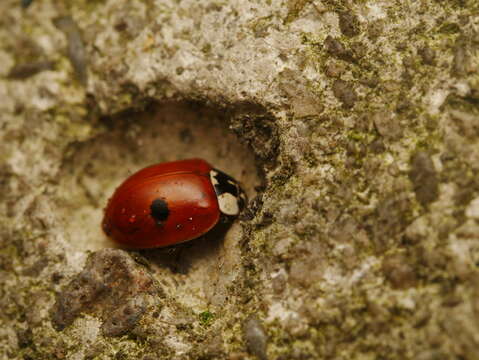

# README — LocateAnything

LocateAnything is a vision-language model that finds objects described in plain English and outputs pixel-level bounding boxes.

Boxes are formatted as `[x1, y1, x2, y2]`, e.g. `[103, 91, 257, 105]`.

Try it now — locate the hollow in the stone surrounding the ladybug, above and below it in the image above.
[54, 103, 279, 313]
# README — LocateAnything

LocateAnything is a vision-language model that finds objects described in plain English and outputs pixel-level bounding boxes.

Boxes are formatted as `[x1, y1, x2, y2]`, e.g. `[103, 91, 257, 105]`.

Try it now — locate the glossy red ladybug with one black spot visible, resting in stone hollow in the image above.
[102, 159, 246, 249]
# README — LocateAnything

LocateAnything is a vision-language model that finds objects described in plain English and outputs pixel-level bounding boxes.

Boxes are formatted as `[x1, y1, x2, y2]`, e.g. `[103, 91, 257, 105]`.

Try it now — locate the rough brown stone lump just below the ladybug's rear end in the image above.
[52, 249, 162, 336]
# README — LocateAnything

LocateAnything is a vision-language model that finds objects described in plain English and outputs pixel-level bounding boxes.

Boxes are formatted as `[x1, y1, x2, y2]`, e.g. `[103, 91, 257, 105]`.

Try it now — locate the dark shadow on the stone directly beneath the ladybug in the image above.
[138, 220, 232, 275]
